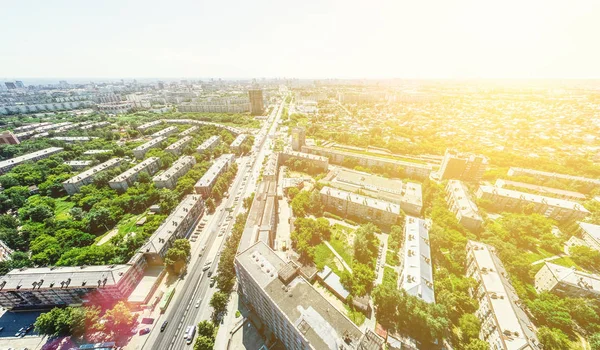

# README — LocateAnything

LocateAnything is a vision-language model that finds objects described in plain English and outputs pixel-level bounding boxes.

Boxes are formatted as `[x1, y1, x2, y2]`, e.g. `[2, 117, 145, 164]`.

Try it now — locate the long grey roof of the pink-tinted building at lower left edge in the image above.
[0, 265, 132, 291]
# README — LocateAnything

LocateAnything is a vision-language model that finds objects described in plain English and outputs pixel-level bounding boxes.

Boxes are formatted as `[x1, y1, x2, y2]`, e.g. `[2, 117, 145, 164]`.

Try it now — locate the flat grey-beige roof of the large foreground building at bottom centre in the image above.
[236, 242, 363, 350]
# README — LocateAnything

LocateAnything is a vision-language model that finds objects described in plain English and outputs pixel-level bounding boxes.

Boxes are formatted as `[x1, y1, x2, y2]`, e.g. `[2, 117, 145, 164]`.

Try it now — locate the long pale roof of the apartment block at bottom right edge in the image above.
[468, 241, 539, 350]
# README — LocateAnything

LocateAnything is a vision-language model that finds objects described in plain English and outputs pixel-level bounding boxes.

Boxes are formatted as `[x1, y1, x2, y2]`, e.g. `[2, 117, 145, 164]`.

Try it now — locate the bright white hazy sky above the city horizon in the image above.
[0, 0, 600, 80]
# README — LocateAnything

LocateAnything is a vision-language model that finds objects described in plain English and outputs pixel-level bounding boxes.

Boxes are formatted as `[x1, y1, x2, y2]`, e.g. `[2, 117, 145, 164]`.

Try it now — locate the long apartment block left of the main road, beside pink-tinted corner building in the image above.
[140, 194, 204, 265]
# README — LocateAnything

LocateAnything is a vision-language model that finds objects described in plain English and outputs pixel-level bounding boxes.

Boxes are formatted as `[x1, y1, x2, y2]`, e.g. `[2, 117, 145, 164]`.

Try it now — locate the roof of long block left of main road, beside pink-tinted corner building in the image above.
[140, 194, 202, 254]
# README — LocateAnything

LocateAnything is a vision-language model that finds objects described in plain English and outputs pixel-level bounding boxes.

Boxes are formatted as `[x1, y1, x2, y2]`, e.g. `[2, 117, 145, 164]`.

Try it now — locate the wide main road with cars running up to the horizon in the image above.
[145, 98, 284, 350]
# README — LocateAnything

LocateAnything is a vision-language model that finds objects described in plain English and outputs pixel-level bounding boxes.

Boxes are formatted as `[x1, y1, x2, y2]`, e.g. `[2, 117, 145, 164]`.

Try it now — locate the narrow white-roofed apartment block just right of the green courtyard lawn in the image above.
[398, 216, 435, 303]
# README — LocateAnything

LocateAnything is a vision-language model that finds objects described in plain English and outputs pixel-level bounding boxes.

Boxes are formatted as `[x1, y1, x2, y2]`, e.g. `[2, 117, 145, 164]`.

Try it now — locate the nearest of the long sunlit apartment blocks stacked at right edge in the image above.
[477, 185, 590, 221]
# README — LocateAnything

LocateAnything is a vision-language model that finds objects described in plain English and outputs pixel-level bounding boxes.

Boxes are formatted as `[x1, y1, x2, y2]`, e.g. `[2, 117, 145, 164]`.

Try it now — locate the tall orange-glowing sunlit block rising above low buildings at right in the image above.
[439, 150, 488, 181]
